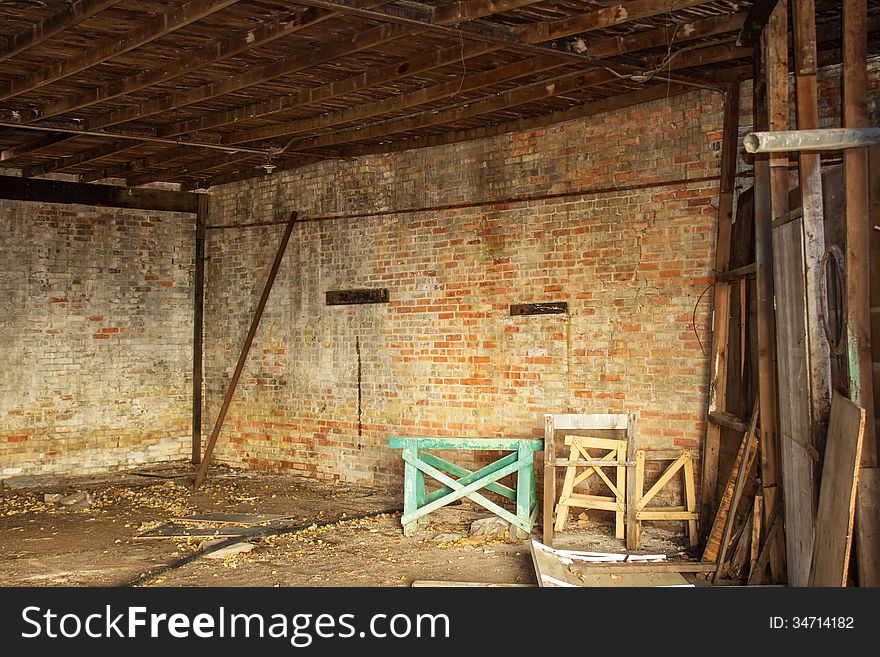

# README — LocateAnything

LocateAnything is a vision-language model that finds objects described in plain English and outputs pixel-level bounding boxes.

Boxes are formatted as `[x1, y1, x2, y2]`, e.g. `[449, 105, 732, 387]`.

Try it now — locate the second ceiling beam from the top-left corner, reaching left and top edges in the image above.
[0, 0, 238, 100]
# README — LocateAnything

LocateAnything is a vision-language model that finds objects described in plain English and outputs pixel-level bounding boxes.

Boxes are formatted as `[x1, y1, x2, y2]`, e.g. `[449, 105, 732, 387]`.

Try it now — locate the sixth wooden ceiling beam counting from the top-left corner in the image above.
[222, 56, 566, 144]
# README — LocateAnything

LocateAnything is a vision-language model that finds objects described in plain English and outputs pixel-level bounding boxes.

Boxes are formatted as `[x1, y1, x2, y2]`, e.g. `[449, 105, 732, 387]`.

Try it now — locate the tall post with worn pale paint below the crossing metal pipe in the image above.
[792, 0, 831, 446]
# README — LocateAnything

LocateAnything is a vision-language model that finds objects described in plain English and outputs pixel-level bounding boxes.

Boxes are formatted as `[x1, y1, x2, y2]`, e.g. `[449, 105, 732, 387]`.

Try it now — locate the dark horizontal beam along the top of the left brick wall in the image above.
[0, 176, 198, 212]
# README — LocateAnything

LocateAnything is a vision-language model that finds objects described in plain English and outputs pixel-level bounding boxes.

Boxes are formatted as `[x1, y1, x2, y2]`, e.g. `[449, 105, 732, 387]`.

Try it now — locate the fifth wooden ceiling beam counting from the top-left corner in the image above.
[157, 42, 500, 137]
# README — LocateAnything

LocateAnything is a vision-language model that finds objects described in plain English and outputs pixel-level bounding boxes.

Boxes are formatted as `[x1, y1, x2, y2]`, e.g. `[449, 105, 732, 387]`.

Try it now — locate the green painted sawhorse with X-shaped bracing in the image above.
[388, 438, 544, 536]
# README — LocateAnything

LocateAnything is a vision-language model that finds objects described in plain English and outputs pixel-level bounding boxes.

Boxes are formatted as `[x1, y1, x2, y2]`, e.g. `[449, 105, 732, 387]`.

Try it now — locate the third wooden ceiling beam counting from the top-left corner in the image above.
[25, 8, 338, 120]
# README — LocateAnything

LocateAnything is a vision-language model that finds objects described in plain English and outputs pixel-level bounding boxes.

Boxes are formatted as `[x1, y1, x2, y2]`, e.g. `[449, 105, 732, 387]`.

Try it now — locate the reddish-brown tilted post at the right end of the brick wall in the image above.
[700, 82, 739, 538]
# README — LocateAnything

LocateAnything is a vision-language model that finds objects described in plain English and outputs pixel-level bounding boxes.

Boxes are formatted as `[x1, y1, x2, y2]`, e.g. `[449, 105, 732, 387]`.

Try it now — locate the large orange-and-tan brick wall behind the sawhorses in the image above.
[205, 86, 721, 498]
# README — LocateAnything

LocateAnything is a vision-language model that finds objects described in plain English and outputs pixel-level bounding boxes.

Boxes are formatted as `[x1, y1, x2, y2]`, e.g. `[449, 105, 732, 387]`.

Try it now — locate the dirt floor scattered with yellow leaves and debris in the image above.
[0, 464, 693, 587]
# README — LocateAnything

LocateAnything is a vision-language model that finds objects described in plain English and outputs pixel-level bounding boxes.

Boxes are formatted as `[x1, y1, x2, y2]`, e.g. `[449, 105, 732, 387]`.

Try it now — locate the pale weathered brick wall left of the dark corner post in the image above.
[0, 201, 194, 478]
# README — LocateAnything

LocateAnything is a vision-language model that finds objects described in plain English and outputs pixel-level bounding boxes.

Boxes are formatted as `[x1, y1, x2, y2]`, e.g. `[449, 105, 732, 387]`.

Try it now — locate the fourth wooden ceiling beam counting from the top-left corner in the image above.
[87, 24, 416, 130]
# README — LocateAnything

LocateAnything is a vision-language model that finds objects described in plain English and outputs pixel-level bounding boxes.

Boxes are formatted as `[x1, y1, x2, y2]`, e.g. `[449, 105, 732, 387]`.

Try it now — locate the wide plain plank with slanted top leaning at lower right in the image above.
[809, 393, 865, 586]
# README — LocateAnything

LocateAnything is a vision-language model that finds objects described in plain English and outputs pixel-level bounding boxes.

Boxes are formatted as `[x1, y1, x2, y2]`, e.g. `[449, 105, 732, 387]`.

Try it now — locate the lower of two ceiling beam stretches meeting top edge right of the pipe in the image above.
[520, 0, 709, 43]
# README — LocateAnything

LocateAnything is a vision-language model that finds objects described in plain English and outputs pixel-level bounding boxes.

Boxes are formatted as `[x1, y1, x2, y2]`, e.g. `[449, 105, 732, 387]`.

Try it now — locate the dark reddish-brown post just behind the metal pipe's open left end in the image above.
[753, 30, 785, 582]
